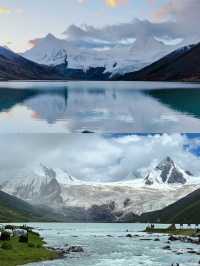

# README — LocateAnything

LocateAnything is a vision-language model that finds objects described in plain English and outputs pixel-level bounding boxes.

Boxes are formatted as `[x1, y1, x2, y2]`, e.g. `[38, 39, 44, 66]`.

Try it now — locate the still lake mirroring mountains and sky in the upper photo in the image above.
[0, 82, 200, 133]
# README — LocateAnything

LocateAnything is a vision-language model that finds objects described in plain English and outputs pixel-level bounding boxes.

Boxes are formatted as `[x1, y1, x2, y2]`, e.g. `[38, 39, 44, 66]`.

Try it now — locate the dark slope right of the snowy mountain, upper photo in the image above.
[119, 44, 200, 81]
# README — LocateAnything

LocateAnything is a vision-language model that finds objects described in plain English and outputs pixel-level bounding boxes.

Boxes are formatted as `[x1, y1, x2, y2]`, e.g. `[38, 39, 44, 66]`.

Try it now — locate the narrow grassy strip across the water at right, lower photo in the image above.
[144, 228, 196, 236]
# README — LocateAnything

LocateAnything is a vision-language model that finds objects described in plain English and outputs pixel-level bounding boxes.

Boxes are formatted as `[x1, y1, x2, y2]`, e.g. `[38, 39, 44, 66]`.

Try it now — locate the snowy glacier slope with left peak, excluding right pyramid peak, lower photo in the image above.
[2, 160, 198, 221]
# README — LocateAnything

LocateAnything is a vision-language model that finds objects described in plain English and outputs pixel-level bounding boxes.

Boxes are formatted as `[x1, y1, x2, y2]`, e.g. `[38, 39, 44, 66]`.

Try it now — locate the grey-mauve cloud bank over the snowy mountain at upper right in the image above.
[64, 0, 200, 47]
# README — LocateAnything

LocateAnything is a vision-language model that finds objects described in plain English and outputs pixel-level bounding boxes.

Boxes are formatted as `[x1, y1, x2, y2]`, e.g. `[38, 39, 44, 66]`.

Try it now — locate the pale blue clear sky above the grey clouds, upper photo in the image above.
[0, 0, 169, 50]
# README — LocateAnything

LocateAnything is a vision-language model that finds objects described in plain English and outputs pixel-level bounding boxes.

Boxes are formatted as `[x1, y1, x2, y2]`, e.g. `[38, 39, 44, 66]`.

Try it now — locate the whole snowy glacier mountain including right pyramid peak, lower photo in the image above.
[1, 157, 199, 222]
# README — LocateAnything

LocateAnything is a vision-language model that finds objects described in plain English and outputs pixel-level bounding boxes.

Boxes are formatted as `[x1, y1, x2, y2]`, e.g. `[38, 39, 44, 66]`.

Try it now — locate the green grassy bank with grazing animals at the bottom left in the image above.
[0, 232, 59, 266]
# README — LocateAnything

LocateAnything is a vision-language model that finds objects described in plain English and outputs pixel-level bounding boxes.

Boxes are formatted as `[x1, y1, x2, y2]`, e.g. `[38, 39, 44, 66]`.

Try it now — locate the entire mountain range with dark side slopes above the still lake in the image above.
[0, 34, 200, 81]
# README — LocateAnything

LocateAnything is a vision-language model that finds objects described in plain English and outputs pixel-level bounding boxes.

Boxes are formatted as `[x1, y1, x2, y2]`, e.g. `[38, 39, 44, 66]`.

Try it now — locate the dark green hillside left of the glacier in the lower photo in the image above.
[0, 191, 64, 223]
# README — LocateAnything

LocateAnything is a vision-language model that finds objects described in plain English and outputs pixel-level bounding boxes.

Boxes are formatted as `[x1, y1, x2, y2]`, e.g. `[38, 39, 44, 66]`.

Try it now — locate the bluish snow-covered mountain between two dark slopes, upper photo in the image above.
[22, 33, 180, 76]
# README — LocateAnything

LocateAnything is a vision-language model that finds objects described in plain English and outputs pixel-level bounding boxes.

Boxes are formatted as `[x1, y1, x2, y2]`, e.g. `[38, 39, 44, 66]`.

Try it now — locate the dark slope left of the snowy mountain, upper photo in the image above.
[0, 47, 62, 80]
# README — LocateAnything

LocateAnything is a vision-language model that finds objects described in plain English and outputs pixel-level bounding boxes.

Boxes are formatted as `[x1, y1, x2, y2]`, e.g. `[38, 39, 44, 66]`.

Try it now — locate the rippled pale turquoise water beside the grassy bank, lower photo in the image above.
[24, 224, 199, 266]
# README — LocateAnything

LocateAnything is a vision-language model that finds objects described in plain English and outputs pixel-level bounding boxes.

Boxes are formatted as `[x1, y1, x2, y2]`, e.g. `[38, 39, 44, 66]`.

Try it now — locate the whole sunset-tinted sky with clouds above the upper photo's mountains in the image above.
[0, 0, 200, 51]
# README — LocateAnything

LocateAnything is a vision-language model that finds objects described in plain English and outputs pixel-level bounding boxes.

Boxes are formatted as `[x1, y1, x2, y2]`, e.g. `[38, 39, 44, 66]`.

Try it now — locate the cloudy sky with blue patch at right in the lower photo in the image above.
[0, 134, 200, 181]
